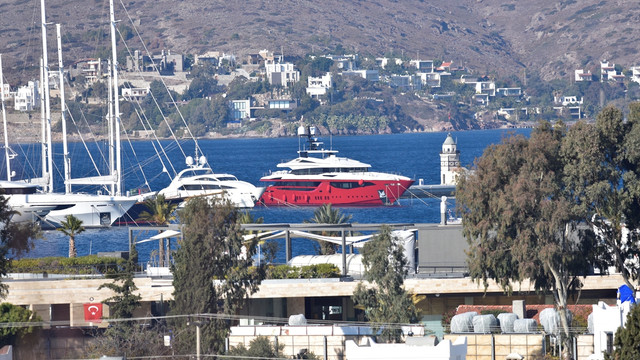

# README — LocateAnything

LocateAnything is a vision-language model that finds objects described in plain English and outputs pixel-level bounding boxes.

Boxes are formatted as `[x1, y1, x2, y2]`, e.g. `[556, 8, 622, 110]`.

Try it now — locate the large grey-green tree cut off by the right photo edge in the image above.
[562, 104, 640, 289]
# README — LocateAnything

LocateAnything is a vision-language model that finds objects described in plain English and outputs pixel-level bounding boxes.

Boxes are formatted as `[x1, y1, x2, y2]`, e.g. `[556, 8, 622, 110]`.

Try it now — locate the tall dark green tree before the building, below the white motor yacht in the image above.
[171, 198, 264, 354]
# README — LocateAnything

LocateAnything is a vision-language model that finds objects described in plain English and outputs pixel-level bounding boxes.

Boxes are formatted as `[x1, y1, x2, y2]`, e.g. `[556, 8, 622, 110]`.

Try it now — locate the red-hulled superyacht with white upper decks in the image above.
[260, 126, 413, 206]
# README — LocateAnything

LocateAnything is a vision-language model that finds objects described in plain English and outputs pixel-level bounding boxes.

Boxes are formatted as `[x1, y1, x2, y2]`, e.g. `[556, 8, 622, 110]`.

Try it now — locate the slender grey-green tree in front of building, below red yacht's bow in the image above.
[353, 225, 417, 342]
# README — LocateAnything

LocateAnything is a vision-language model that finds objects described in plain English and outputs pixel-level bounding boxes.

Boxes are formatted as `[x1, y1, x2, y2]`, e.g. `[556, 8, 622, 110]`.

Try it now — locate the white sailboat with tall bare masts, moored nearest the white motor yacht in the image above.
[5, 0, 137, 227]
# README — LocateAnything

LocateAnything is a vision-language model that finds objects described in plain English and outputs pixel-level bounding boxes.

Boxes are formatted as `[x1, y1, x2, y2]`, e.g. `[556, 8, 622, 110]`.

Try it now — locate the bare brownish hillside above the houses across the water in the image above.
[0, 0, 640, 83]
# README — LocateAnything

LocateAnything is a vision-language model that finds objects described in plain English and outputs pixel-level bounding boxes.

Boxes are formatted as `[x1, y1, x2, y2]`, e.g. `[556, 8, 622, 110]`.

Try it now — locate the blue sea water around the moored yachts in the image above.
[0, 129, 530, 262]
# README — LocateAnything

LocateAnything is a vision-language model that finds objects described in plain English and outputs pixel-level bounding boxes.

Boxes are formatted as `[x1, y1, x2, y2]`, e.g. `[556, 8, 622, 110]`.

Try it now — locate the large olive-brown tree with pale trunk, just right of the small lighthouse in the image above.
[456, 123, 598, 358]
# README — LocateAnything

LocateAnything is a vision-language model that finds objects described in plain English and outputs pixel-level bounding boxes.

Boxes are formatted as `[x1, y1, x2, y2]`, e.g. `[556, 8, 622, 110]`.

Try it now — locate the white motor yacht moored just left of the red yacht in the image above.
[158, 156, 264, 208]
